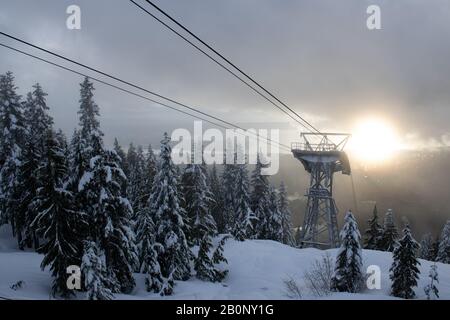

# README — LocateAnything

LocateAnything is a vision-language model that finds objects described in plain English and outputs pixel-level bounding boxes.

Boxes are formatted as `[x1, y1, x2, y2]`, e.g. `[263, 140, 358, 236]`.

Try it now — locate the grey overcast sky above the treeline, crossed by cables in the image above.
[0, 0, 450, 150]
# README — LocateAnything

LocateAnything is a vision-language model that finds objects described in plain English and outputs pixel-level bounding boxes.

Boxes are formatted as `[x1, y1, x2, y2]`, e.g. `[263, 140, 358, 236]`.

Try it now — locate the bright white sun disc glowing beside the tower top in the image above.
[349, 118, 400, 163]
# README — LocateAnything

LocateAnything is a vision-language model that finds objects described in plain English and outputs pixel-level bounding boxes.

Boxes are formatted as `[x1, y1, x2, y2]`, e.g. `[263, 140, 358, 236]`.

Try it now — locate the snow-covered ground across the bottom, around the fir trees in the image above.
[0, 225, 450, 299]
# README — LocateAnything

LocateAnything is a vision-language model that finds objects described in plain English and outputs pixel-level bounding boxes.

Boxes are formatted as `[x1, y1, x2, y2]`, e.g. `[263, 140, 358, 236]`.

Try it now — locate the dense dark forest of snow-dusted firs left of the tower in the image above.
[0, 72, 294, 299]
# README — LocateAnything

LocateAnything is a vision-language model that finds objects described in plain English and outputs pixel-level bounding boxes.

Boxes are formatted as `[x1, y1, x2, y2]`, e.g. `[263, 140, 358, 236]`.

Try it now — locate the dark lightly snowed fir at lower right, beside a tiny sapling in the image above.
[389, 226, 420, 299]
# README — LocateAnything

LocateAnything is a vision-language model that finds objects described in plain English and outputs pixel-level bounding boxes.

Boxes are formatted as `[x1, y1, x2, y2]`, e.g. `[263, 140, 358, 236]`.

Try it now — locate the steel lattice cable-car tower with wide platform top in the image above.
[292, 133, 351, 248]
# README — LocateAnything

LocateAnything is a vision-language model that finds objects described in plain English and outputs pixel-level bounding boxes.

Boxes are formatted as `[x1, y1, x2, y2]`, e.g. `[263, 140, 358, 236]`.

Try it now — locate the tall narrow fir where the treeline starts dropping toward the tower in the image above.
[250, 154, 273, 239]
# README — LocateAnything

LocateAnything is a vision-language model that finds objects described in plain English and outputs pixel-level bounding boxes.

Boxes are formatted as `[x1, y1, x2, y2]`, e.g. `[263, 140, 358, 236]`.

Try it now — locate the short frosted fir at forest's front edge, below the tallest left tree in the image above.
[81, 241, 113, 300]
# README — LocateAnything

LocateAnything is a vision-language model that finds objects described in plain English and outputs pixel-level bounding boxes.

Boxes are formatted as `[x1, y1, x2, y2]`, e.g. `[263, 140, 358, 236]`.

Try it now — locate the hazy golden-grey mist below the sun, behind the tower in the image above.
[271, 148, 450, 238]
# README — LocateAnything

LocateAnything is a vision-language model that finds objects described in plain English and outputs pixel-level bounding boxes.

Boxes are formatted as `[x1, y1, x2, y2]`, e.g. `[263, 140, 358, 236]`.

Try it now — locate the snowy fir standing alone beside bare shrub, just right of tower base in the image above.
[331, 211, 363, 293]
